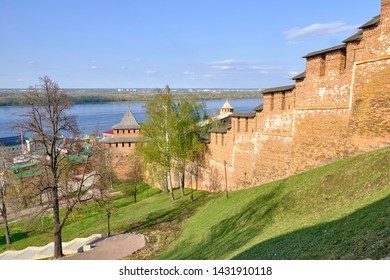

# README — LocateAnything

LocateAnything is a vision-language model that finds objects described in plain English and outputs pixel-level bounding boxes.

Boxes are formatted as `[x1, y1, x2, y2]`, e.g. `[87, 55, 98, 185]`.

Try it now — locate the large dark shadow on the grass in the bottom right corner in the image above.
[233, 196, 390, 260]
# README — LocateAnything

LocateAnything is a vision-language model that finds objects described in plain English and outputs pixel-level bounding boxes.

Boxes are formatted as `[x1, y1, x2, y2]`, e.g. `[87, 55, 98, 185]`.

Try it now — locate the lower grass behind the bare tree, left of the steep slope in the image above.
[0, 184, 214, 258]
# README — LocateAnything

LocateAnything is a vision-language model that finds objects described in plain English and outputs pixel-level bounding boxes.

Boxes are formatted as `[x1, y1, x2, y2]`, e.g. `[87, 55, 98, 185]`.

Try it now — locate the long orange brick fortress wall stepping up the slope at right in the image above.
[197, 0, 390, 191]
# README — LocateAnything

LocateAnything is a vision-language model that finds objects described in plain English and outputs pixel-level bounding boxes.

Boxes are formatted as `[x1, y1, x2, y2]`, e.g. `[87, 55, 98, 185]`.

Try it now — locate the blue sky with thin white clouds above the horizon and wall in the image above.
[0, 0, 380, 88]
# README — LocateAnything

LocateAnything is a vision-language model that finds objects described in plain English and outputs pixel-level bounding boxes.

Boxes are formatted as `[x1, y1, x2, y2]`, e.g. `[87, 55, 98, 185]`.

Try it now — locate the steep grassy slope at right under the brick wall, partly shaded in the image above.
[159, 147, 390, 259]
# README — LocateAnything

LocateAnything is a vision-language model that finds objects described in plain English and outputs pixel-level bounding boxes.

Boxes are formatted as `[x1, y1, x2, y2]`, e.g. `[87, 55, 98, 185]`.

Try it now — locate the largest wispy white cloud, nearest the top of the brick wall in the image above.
[282, 22, 358, 39]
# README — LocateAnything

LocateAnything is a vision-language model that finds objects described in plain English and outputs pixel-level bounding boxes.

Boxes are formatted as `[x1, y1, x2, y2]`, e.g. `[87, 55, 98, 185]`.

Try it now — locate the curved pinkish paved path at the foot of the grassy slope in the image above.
[62, 233, 147, 260]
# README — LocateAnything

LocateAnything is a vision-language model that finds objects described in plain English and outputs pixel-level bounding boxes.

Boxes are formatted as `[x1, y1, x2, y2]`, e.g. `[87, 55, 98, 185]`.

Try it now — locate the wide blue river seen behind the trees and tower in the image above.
[0, 99, 263, 137]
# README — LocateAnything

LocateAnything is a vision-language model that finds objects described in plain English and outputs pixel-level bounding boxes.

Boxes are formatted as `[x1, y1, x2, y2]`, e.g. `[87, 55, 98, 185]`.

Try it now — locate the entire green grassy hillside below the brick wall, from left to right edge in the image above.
[0, 147, 390, 259]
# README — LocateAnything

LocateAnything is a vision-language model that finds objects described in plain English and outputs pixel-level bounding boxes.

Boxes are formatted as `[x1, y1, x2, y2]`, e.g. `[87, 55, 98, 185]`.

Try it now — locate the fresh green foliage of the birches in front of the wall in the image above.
[138, 86, 207, 195]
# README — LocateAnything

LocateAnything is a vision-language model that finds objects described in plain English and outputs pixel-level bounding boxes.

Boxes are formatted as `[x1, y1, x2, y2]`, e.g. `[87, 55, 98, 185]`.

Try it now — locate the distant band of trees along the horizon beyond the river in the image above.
[0, 91, 262, 106]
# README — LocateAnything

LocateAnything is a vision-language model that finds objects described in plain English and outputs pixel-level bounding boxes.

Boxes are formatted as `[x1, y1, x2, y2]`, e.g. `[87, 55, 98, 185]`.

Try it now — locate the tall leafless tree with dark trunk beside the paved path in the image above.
[18, 76, 100, 258]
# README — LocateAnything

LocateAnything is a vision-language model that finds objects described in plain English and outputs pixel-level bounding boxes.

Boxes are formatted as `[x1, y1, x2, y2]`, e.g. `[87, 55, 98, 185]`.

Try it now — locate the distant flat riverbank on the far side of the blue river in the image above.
[0, 89, 262, 106]
